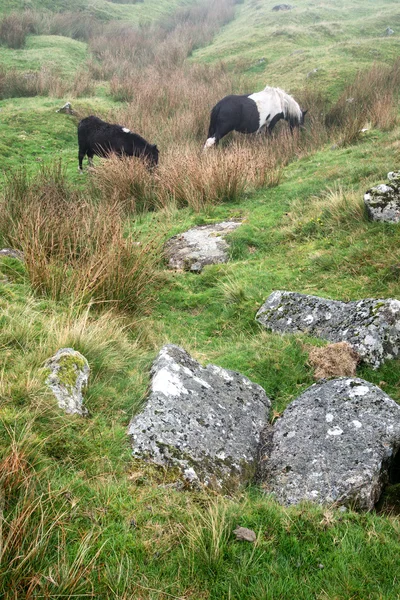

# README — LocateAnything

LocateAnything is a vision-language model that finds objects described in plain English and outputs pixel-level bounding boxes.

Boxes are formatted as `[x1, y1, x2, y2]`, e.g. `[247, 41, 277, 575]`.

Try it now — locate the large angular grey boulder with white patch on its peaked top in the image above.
[129, 345, 270, 489]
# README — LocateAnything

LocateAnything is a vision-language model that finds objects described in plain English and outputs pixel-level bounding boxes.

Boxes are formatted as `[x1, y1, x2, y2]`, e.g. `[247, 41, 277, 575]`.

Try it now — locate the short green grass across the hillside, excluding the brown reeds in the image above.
[0, 0, 400, 600]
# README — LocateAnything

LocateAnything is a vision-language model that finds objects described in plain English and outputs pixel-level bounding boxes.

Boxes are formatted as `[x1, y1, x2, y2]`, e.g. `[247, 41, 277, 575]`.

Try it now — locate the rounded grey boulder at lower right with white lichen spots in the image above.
[261, 378, 400, 510]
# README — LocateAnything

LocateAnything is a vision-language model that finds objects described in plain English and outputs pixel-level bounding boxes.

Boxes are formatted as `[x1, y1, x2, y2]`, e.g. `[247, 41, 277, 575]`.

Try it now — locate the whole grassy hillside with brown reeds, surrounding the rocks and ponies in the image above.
[0, 0, 400, 600]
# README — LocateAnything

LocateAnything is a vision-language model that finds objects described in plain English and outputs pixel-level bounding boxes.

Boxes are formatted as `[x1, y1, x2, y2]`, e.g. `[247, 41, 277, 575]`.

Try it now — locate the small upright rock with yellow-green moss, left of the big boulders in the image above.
[44, 348, 90, 416]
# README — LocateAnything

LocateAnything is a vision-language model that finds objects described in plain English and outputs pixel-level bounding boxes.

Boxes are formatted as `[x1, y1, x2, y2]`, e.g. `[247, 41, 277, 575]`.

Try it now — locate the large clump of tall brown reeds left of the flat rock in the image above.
[0, 163, 159, 312]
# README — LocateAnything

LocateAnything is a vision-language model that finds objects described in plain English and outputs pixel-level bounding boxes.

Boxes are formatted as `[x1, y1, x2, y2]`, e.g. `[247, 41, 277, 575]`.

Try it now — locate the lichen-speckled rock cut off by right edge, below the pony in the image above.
[364, 172, 400, 223]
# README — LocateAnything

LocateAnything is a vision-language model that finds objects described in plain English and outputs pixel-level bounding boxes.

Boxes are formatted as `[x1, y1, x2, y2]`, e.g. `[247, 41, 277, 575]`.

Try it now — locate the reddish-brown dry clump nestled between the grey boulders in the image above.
[308, 342, 360, 379]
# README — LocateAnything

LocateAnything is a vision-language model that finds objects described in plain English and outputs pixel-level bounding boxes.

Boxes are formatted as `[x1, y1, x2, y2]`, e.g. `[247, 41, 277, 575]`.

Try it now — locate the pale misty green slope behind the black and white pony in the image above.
[194, 0, 400, 95]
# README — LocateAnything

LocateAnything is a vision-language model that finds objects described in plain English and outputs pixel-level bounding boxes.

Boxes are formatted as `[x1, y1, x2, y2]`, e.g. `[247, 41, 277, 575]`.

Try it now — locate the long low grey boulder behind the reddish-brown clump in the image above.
[256, 291, 400, 368]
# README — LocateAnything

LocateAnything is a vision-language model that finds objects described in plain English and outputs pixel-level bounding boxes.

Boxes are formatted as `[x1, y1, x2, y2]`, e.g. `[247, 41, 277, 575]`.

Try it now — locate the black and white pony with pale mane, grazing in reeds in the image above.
[204, 86, 307, 148]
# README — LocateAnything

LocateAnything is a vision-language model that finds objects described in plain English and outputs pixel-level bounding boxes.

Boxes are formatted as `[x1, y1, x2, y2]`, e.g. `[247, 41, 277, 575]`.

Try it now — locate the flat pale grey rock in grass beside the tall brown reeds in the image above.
[164, 221, 241, 273]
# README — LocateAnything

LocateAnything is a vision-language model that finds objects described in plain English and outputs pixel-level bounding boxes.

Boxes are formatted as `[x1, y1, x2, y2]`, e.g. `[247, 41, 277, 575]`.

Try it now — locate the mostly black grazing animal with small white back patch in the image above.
[78, 116, 158, 171]
